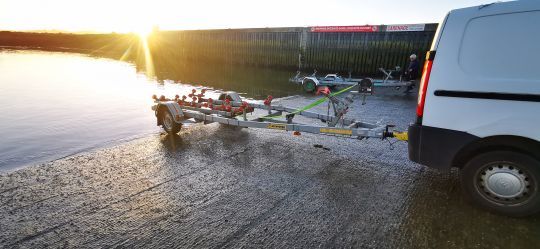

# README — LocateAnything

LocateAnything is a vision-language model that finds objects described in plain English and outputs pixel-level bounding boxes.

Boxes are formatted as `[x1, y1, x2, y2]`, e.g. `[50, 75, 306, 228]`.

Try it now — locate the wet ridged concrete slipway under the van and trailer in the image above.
[0, 92, 540, 248]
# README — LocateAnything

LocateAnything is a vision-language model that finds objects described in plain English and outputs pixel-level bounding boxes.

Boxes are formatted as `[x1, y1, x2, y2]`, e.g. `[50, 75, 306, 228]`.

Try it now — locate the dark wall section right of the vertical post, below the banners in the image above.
[302, 27, 436, 76]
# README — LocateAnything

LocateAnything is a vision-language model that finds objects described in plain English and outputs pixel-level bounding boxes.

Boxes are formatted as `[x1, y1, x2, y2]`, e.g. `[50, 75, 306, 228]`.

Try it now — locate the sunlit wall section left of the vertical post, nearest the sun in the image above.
[150, 29, 301, 69]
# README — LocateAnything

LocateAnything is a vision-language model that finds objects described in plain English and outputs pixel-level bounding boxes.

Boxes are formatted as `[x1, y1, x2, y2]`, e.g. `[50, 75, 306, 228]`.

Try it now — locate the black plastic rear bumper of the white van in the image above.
[408, 124, 478, 169]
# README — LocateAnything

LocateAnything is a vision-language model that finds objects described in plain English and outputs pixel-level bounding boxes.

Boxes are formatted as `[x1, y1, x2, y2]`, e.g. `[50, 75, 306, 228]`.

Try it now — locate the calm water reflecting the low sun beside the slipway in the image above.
[0, 50, 298, 171]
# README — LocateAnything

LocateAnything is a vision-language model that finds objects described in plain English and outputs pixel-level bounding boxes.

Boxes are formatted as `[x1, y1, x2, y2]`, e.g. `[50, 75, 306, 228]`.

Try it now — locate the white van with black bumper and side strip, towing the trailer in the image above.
[409, 0, 540, 216]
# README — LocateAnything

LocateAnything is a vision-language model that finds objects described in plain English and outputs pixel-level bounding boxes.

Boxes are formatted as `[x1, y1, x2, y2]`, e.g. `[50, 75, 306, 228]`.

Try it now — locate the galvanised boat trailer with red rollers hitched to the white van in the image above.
[152, 89, 407, 140]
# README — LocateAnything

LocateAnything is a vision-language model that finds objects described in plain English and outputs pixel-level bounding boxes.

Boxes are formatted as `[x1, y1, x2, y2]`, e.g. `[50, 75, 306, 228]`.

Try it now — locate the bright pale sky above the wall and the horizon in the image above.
[0, 0, 495, 33]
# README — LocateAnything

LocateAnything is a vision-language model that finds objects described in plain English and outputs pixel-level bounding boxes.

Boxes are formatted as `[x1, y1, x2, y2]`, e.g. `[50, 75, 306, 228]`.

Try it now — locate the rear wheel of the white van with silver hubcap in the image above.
[460, 151, 540, 217]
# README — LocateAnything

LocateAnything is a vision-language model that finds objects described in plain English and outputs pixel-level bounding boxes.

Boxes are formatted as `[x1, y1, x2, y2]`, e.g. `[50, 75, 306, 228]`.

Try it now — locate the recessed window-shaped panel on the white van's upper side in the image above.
[459, 11, 540, 80]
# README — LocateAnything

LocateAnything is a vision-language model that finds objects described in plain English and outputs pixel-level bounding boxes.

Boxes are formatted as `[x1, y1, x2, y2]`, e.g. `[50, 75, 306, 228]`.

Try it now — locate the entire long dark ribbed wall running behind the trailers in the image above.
[150, 24, 437, 76]
